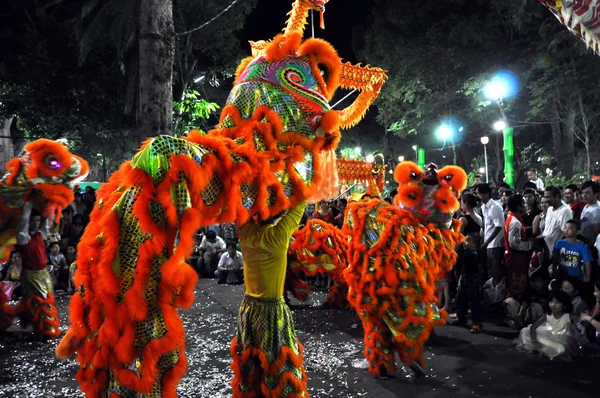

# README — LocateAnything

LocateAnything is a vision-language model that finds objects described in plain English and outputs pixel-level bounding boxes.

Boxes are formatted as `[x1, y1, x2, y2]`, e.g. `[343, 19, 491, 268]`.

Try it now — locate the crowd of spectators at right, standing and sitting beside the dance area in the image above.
[450, 170, 600, 357]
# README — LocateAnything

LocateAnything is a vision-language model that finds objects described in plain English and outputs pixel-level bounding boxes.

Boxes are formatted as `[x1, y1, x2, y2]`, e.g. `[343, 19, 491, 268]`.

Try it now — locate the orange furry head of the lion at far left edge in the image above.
[0, 139, 89, 220]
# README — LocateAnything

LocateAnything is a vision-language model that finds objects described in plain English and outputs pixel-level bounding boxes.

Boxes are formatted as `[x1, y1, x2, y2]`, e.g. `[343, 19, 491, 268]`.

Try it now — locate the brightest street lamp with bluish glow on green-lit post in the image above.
[483, 71, 519, 188]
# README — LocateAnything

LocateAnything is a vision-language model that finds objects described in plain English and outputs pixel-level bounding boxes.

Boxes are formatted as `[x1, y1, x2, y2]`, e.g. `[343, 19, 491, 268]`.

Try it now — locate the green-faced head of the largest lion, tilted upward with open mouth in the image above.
[219, 0, 387, 185]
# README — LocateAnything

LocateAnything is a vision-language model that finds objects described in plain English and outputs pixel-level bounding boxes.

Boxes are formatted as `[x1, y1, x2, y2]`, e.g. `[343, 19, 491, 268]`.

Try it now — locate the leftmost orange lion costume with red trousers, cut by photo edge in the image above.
[0, 139, 88, 337]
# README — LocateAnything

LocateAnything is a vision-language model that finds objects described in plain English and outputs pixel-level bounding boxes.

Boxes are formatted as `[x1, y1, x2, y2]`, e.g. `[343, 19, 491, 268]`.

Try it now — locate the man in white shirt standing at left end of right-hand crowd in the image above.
[475, 183, 504, 285]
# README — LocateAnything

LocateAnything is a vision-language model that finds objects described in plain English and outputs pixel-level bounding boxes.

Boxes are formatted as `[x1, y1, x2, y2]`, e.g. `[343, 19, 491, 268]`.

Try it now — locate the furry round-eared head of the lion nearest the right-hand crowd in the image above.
[394, 162, 467, 225]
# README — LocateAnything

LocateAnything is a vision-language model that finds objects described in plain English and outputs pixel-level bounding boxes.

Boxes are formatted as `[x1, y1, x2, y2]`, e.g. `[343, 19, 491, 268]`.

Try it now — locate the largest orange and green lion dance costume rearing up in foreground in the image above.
[56, 0, 386, 398]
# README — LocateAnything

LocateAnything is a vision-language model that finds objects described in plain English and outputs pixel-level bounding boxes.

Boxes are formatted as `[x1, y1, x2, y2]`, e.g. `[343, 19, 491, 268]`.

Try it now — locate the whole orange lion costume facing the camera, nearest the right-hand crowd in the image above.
[342, 162, 467, 376]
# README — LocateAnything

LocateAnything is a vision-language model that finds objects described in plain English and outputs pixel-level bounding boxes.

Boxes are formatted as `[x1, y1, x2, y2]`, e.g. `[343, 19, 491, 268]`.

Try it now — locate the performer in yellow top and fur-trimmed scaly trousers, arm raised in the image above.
[231, 201, 308, 398]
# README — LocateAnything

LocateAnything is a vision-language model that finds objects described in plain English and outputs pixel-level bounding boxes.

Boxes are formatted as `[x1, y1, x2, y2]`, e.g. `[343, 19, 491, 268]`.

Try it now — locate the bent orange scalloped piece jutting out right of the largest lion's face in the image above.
[337, 62, 387, 129]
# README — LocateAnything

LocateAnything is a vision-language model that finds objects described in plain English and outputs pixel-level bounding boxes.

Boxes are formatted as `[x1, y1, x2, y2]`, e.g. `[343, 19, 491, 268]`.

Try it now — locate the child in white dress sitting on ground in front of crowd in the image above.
[515, 291, 579, 361]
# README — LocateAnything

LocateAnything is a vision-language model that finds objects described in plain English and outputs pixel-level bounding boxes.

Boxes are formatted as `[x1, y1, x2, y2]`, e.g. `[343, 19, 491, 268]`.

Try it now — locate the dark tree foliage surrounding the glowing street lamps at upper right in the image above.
[355, 0, 600, 178]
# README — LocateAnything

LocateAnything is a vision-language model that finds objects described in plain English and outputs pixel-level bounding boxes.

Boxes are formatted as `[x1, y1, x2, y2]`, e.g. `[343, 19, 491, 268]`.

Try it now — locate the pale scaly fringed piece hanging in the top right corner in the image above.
[541, 0, 600, 55]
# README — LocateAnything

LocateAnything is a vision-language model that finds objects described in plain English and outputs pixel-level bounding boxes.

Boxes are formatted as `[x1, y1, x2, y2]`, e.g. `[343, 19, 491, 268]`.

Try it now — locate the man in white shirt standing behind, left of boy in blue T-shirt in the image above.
[538, 186, 573, 260]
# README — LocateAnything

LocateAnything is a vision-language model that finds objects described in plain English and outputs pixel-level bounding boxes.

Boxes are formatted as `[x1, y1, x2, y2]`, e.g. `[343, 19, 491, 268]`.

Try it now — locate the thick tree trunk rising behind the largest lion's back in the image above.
[137, 0, 175, 140]
